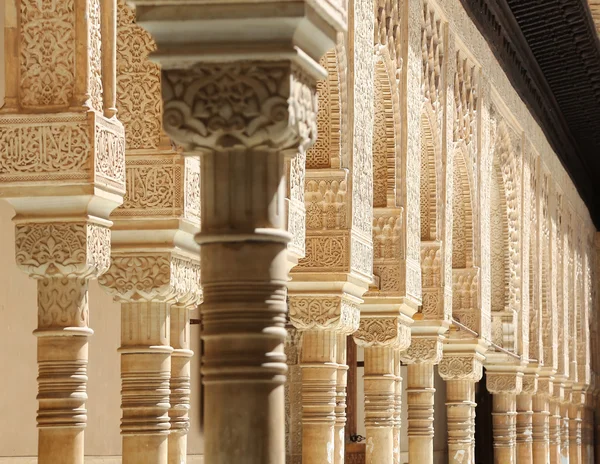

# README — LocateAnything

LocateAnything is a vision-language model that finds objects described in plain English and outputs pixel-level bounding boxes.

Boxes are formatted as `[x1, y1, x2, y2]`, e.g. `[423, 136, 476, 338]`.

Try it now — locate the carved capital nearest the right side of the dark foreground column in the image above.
[289, 296, 360, 335]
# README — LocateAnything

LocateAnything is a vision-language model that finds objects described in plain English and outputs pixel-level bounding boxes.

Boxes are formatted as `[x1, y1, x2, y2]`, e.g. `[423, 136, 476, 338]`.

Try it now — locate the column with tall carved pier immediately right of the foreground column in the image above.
[288, 1, 375, 464]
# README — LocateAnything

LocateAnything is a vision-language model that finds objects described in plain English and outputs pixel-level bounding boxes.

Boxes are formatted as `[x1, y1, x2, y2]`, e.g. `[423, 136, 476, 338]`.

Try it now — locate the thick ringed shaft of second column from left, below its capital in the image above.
[119, 302, 173, 464]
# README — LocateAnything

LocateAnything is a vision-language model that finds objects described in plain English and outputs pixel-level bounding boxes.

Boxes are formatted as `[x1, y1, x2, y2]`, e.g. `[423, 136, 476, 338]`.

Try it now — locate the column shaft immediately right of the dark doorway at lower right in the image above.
[492, 393, 517, 464]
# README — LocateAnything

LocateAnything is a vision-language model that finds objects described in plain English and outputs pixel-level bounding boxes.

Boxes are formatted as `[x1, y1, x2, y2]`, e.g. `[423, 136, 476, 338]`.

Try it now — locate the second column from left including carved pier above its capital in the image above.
[100, 5, 200, 464]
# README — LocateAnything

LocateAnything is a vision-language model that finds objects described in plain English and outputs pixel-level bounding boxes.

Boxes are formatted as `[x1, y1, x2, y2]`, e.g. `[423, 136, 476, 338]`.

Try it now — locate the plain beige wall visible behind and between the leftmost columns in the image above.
[0, 202, 202, 458]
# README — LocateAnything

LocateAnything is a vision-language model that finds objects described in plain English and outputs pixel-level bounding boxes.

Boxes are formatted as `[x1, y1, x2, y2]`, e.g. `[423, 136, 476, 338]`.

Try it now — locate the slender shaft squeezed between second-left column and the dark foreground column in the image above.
[169, 304, 194, 464]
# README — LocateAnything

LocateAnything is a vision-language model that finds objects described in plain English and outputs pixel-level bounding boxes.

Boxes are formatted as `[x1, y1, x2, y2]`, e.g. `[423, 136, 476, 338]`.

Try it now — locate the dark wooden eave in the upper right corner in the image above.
[461, 0, 600, 229]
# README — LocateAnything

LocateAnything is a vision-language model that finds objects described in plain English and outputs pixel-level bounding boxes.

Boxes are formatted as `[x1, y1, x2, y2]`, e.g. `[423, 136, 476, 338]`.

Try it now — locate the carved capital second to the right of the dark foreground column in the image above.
[354, 317, 410, 351]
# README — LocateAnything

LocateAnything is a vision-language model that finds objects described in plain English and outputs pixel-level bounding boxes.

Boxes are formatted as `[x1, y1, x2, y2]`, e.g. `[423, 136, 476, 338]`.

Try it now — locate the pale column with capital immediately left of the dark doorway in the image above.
[438, 352, 484, 464]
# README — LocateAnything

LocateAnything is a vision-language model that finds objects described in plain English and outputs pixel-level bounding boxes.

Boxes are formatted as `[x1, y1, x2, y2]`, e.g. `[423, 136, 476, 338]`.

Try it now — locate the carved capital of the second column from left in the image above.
[99, 252, 200, 303]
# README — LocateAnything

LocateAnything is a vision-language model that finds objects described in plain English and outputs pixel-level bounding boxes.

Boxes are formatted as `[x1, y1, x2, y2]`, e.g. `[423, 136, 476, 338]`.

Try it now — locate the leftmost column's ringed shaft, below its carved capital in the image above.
[34, 277, 93, 464]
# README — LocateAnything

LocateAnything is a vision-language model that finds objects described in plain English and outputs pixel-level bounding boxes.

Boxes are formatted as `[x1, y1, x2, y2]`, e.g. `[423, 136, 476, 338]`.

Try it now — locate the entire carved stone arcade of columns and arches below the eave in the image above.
[0, 0, 600, 464]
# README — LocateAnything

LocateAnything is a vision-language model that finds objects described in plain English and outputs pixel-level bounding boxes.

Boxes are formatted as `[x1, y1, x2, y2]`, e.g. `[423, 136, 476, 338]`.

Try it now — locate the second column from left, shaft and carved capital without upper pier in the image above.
[100, 254, 199, 464]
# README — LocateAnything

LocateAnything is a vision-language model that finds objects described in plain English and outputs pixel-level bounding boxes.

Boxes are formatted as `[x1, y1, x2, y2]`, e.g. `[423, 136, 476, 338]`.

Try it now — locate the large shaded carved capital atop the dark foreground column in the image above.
[163, 61, 317, 156]
